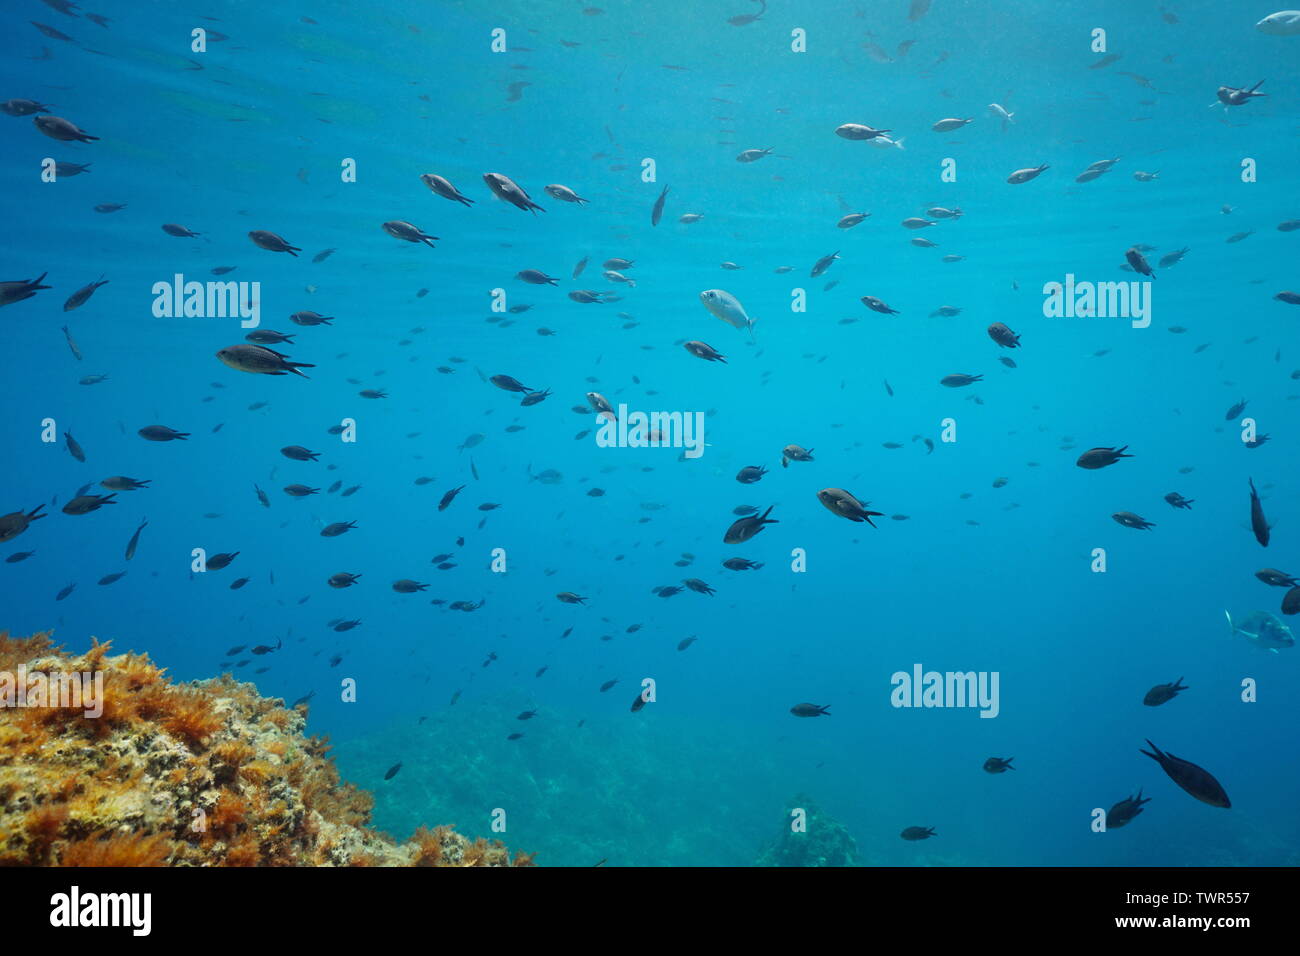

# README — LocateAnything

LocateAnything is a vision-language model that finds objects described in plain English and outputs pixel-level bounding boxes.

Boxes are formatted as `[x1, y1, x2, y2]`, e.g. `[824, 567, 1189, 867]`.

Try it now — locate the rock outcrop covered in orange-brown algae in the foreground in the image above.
[0, 632, 532, 866]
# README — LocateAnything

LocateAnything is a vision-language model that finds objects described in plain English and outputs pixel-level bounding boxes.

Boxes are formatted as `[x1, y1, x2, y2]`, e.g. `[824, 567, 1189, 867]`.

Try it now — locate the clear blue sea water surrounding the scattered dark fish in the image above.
[0, 0, 1300, 865]
